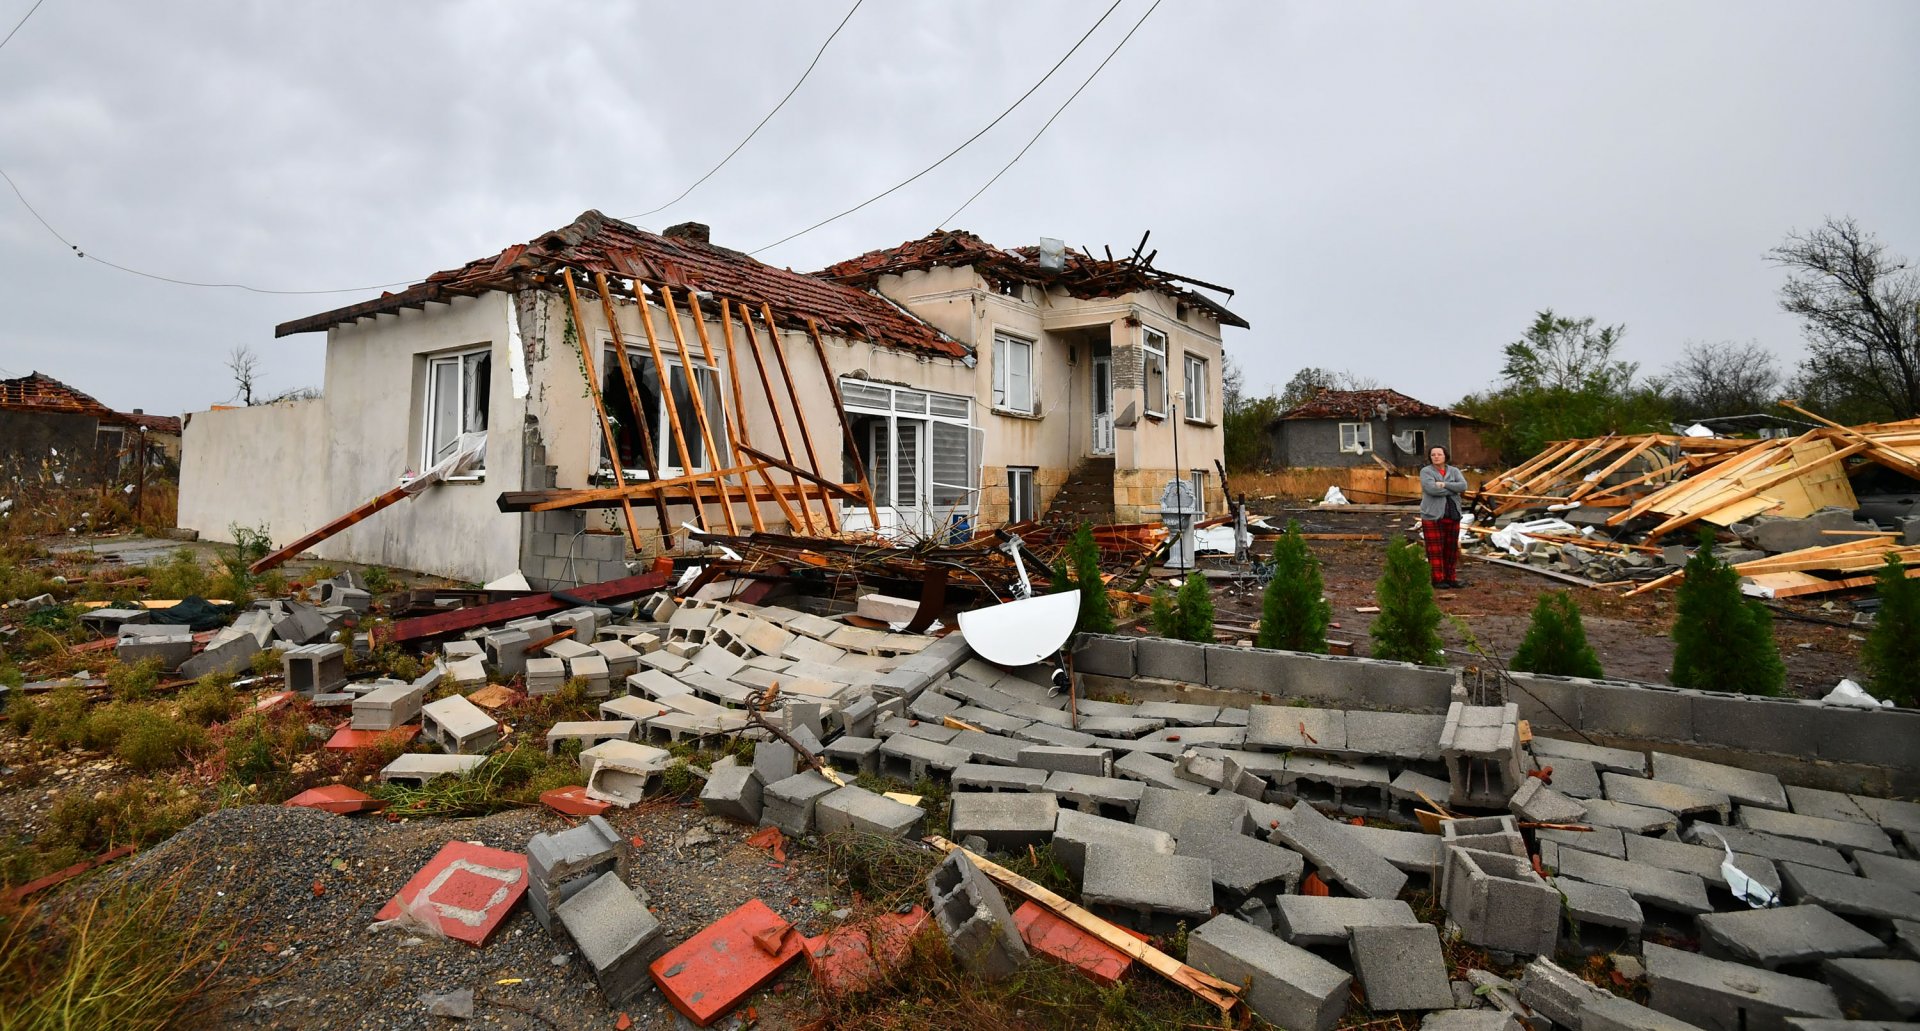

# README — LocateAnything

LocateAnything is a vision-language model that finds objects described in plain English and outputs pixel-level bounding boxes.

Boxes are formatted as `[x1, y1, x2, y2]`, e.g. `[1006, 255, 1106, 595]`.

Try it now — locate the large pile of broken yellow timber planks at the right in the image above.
[1463, 420, 1920, 597]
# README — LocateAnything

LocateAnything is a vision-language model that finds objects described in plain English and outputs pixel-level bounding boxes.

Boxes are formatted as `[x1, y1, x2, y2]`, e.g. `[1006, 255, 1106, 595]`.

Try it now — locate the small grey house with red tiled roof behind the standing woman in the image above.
[1267, 388, 1496, 468]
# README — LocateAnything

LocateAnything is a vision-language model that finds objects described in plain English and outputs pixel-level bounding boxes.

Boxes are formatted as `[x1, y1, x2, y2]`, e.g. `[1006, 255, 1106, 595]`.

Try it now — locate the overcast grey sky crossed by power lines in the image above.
[0, 0, 1920, 413]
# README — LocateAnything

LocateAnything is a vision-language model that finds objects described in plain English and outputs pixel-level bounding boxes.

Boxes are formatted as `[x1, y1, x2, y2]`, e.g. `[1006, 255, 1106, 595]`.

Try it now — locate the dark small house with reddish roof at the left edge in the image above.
[0, 372, 136, 482]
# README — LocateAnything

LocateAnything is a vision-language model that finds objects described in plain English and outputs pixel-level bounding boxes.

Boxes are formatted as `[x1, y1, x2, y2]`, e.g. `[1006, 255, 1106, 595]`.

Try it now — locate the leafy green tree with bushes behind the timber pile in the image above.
[1455, 309, 1670, 463]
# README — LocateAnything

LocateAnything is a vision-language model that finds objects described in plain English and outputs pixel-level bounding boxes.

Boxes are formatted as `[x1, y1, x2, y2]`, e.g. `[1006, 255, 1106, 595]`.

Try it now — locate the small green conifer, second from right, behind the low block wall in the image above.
[1672, 530, 1788, 695]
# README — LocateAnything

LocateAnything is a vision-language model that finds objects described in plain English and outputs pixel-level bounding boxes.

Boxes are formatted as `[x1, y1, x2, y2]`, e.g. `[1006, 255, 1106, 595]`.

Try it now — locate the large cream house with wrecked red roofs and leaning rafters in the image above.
[180, 211, 1246, 584]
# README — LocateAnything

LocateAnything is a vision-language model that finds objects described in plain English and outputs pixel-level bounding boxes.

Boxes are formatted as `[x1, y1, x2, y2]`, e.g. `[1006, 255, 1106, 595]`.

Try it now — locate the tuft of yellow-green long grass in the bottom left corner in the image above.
[0, 870, 238, 1031]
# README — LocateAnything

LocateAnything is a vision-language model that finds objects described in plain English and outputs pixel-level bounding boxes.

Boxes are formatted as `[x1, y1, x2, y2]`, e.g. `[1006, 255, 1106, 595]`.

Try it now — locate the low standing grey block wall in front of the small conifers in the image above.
[1073, 635, 1920, 795]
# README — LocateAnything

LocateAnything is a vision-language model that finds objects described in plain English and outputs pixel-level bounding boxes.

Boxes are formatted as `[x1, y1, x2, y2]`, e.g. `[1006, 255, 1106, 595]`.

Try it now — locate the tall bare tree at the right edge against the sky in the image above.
[1768, 219, 1920, 420]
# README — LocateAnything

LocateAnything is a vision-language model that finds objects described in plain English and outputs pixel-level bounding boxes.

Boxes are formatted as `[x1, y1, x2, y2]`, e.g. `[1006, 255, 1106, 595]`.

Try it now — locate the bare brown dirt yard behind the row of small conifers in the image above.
[1213, 505, 1864, 697]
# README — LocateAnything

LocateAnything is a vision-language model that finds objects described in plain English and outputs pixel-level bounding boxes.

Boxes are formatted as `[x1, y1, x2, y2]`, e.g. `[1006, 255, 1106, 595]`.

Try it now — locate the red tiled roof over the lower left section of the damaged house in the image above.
[275, 211, 970, 357]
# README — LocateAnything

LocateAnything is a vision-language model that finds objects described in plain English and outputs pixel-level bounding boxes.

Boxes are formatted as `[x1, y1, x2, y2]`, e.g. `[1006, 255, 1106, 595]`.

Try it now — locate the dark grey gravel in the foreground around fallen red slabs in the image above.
[111, 804, 837, 1029]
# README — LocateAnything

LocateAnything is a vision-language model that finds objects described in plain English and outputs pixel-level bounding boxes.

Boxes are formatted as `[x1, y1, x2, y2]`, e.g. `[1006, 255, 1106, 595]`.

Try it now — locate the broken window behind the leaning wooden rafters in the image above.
[601, 348, 726, 480]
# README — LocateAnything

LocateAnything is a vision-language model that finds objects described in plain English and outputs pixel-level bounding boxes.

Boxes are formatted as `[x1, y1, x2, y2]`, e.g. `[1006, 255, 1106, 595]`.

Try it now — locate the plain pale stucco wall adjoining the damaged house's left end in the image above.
[179, 399, 326, 545]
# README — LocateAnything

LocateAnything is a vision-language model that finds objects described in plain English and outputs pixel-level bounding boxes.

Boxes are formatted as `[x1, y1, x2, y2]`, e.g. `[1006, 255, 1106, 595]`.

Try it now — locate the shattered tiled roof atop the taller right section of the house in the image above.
[814, 230, 1246, 328]
